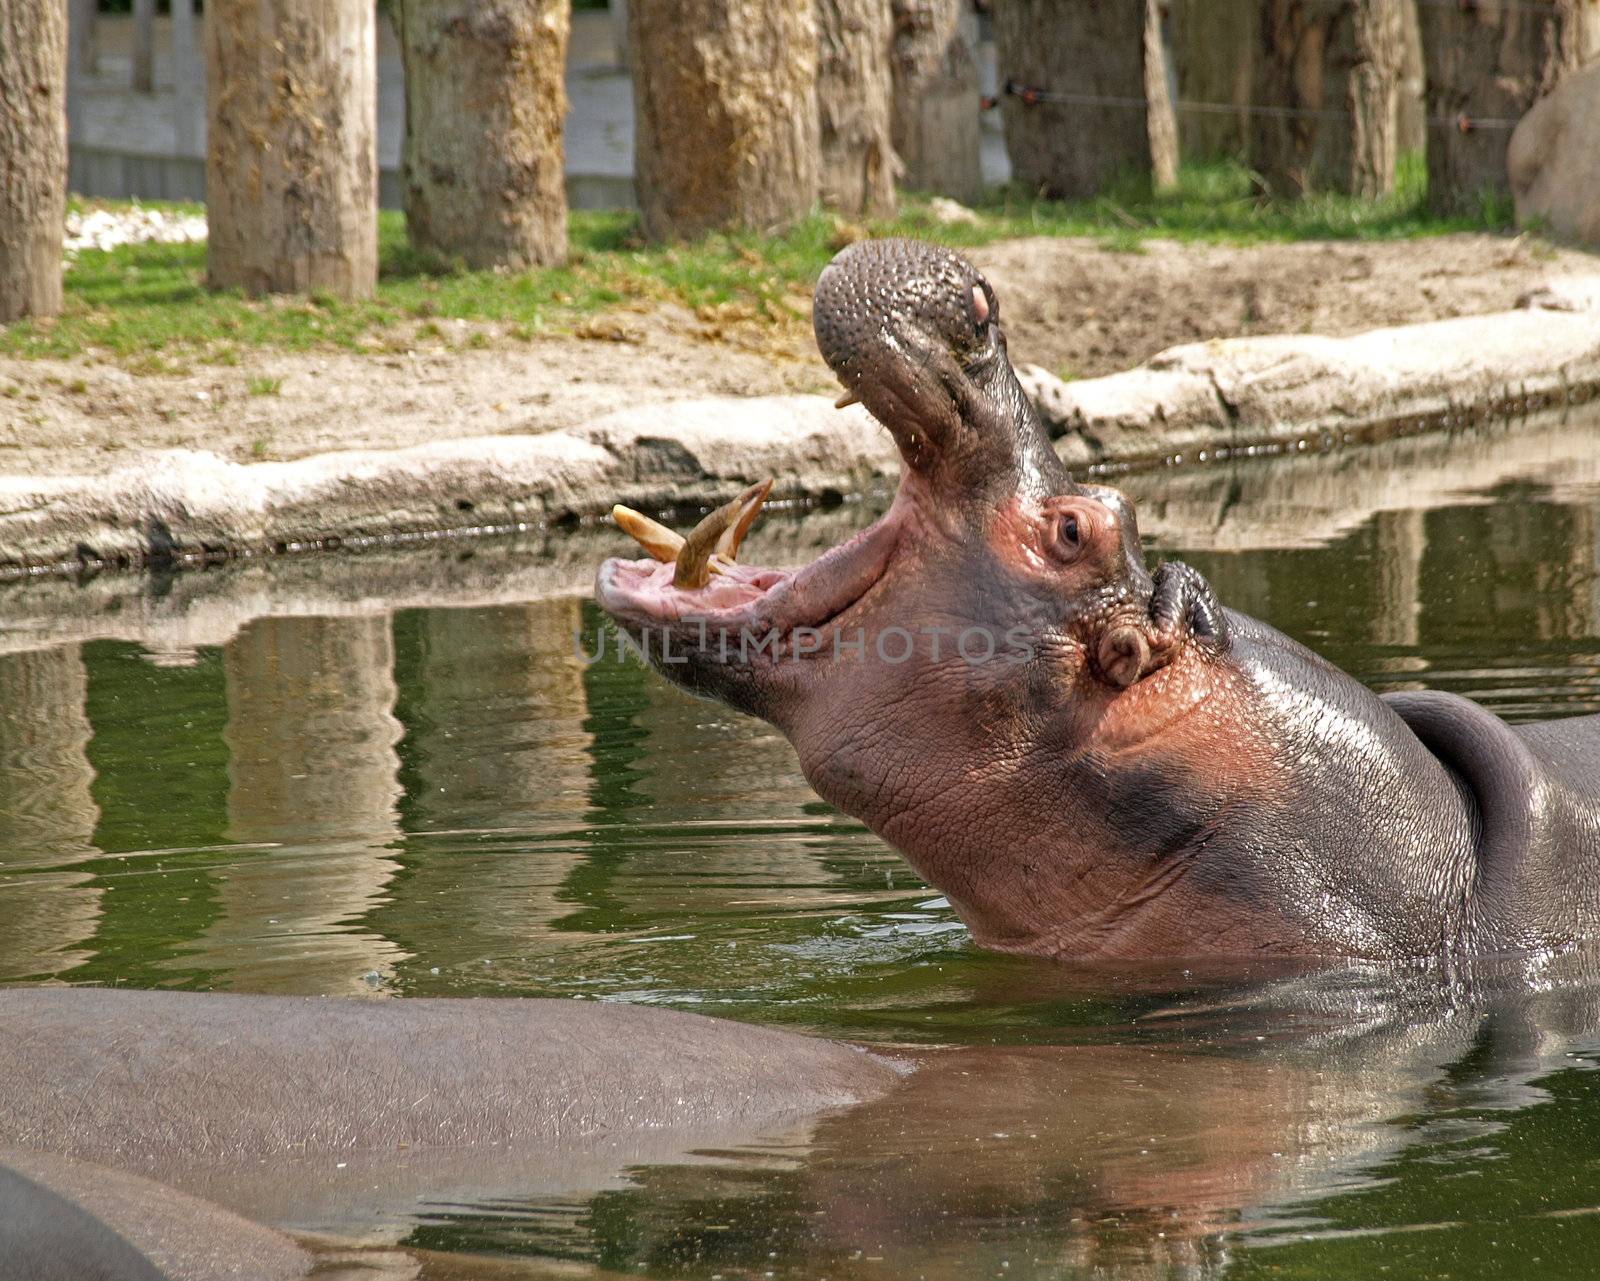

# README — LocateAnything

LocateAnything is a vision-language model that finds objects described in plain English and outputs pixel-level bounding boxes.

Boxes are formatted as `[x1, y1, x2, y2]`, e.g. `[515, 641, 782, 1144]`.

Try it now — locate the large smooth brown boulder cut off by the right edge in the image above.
[1506, 66, 1600, 245]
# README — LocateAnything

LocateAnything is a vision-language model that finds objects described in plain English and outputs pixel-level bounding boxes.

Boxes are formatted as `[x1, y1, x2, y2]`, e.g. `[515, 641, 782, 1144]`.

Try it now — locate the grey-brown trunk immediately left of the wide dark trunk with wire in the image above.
[890, 0, 984, 200]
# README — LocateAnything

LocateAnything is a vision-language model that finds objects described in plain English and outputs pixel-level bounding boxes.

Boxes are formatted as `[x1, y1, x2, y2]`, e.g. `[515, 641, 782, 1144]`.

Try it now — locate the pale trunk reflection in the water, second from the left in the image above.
[184, 616, 403, 995]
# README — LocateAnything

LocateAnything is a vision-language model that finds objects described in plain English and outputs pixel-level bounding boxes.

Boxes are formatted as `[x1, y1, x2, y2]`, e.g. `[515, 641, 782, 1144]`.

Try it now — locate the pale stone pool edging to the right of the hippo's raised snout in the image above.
[1019, 299, 1600, 465]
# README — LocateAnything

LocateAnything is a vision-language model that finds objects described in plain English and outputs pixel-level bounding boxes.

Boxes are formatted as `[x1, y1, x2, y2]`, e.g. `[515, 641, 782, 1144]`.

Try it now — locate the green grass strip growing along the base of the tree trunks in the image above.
[0, 157, 1509, 364]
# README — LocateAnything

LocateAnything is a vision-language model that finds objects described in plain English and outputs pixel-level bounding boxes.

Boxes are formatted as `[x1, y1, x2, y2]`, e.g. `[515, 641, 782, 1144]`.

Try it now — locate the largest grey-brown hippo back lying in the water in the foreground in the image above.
[0, 988, 899, 1167]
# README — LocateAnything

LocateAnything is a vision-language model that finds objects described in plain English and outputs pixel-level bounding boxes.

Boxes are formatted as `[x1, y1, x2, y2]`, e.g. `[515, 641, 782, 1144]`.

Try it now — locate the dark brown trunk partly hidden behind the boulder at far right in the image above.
[1418, 0, 1600, 214]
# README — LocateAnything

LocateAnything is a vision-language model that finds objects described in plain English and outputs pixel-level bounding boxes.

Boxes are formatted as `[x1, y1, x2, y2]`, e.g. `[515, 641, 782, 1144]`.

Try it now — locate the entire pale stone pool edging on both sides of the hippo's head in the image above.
[0, 288, 1600, 577]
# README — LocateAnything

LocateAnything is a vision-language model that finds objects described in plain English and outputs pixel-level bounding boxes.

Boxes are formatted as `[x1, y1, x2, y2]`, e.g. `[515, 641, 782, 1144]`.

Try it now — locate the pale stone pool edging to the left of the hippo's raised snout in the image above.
[0, 397, 898, 576]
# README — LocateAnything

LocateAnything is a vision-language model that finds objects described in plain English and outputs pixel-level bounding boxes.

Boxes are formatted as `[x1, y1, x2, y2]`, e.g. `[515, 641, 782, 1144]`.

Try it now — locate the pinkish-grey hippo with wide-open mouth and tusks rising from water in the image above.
[597, 241, 1600, 958]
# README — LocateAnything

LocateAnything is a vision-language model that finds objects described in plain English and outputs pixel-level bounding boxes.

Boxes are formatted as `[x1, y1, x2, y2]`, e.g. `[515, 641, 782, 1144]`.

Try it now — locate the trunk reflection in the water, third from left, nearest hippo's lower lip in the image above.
[373, 598, 594, 972]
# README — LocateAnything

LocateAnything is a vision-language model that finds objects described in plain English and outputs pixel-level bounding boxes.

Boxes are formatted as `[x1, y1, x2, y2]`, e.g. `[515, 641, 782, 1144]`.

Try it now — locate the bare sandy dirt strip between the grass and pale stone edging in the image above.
[0, 235, 1600, 477]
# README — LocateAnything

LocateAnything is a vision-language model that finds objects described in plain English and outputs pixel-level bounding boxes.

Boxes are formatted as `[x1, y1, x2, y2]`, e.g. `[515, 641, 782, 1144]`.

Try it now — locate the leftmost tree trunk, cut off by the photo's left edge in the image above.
[0, 0, 67, 325]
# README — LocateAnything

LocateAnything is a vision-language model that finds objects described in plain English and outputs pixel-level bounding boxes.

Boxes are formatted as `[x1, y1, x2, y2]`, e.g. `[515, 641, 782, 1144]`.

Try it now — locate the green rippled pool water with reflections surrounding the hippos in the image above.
[0, 424, 1600, 1281]
